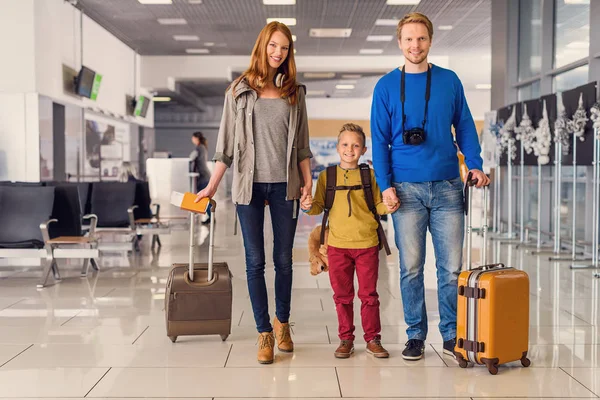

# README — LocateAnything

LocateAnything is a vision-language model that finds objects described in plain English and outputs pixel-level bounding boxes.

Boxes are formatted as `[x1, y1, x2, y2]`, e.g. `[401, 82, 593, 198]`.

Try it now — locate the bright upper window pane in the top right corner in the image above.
[554, 0, 590, 68]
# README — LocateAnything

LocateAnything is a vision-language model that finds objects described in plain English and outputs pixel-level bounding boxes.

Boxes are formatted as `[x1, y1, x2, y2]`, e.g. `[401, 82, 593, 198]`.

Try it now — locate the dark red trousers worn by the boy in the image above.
[327, 246, 381, 342]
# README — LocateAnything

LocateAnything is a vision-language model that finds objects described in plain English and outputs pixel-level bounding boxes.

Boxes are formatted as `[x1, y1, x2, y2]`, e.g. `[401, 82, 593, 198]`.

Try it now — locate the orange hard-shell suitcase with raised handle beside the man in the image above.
[454, 176, 530, 375]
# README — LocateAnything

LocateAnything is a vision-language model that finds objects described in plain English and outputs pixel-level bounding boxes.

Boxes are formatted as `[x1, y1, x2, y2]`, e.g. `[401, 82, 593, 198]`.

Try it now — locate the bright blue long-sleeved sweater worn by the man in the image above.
[371, 65, 483, 191]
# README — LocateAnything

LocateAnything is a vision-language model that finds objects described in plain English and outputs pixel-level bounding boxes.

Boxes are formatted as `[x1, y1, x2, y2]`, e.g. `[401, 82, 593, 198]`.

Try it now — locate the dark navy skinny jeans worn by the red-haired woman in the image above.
[237, 183, 298, 332]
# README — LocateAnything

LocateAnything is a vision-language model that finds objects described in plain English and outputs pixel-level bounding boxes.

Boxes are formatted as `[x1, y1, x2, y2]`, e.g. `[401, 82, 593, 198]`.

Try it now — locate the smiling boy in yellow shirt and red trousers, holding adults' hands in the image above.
[300, 124, 398, 358]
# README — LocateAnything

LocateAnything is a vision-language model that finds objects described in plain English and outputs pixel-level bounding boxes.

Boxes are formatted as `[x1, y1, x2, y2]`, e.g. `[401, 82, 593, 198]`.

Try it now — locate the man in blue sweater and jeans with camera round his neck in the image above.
[371, 13, 489, 360]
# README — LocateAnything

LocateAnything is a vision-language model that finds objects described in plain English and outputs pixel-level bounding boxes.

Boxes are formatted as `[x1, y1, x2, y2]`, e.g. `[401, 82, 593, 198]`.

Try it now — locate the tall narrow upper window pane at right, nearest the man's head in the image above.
[519, 0, 542, 81]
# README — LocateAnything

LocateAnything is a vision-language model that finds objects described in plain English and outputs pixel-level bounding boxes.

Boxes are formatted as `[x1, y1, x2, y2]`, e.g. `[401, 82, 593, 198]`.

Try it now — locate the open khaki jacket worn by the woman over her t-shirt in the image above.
[213, 80, 312, 205]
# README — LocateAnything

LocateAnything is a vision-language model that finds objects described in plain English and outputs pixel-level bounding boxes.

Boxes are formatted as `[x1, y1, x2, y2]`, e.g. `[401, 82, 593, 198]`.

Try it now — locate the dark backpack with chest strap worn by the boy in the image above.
[321, 164, 392, 256]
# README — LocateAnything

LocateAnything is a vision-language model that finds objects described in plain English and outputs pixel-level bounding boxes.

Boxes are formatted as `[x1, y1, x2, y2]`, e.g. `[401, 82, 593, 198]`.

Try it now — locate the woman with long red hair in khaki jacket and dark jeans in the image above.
[197, 22, 312, 364]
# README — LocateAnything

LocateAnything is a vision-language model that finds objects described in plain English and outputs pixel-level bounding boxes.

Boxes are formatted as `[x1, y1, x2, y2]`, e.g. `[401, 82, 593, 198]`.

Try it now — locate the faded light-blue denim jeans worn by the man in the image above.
[392, 178, 464, 341]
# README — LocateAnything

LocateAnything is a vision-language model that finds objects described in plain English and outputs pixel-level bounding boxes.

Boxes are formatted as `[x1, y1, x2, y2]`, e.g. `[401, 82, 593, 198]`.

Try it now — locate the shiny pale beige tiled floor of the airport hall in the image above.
[0, 199, 600, 400]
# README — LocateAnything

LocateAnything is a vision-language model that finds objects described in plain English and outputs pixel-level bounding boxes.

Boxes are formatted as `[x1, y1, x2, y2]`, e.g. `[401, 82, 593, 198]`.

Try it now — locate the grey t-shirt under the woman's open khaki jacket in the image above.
[252, 98, 290, 183]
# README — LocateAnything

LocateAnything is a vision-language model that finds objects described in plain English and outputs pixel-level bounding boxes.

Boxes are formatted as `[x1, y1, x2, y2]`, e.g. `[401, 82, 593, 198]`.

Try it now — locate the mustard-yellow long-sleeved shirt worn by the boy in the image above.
[308, 165, 388, 249]
